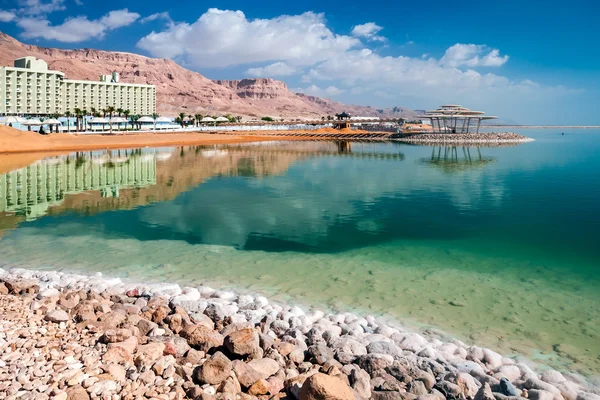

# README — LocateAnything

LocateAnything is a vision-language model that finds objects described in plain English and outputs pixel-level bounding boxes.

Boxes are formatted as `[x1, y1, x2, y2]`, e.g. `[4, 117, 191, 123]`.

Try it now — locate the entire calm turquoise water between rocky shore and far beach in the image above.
[0, 130, 600, 375]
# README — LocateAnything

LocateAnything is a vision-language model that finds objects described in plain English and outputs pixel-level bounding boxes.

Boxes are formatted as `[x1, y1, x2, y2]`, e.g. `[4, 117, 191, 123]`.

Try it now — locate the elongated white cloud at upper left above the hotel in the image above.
[17, 9, 140, 43]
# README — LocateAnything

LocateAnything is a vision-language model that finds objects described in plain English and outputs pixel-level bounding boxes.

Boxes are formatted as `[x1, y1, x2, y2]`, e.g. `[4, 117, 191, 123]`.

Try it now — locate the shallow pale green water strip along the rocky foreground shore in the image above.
[0, 230, 600, 375]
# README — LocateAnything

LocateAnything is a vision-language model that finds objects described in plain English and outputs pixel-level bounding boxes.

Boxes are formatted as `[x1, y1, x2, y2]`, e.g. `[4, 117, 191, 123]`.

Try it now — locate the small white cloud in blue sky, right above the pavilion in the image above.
[441, 43, 508, 67]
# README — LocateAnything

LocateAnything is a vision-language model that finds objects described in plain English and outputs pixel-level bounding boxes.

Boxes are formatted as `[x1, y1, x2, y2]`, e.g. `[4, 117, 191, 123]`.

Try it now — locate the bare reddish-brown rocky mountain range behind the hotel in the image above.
[0, 32, 412, 118]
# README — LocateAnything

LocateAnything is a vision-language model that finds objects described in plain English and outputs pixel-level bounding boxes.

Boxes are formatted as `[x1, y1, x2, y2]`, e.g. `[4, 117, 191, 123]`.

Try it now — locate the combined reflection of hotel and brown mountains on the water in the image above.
[0, 141, 404, 231]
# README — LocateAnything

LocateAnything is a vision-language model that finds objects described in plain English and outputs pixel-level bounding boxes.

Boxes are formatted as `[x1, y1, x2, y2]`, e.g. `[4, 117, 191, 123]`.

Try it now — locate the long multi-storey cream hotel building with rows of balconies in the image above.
[0, 57, 156, 116]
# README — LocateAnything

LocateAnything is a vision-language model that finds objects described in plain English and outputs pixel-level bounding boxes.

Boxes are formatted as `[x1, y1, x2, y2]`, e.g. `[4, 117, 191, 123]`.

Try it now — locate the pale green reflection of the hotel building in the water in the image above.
[0, 150, 156, 220]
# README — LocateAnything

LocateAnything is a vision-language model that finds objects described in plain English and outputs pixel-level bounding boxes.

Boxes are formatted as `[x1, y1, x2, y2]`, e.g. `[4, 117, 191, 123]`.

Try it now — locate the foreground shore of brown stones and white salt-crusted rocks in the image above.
[0, 269, 600, 400]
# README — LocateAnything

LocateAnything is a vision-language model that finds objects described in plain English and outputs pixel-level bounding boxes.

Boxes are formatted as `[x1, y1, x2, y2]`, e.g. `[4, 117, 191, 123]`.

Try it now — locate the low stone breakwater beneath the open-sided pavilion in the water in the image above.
[393, 132, 534, 144]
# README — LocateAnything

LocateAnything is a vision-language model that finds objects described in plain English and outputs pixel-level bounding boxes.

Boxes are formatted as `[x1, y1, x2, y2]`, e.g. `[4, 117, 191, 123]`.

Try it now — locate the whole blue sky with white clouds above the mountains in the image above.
[0, 0, 600, 125]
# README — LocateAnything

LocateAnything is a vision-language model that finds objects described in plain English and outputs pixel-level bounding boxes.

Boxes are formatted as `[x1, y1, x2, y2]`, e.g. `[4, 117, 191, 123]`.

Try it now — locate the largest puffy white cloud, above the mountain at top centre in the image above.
[138, 8, 360, 67]
